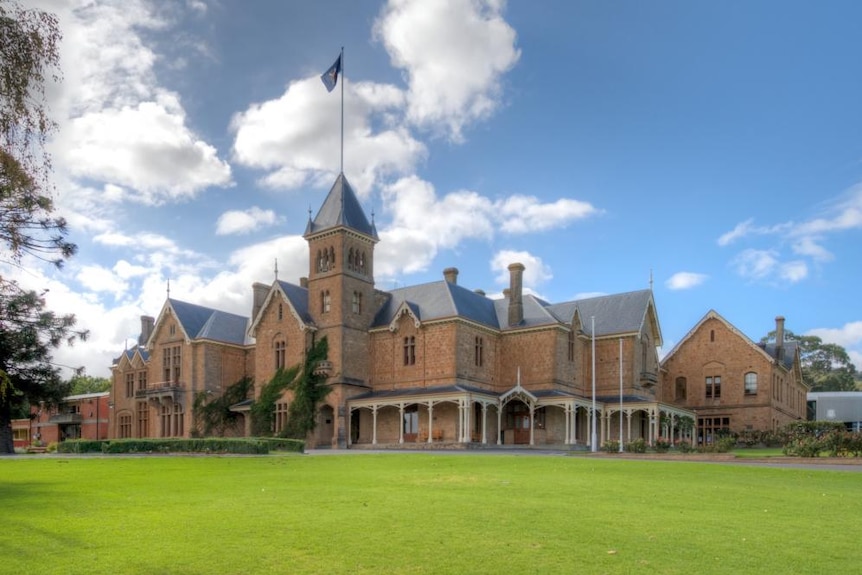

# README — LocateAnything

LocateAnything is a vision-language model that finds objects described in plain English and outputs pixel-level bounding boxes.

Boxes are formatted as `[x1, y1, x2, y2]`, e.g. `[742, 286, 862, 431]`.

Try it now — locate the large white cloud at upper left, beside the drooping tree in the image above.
[44, 0, 231, 207]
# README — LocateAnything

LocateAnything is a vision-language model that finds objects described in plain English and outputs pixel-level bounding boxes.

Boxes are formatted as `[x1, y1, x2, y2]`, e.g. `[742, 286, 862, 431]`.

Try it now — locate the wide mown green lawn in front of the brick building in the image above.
[0, 454, 862, 575]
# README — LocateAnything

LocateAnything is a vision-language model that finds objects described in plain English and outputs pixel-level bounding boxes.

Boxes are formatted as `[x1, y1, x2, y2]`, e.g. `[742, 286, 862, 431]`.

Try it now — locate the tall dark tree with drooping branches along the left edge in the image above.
[0, 4, 87, 453]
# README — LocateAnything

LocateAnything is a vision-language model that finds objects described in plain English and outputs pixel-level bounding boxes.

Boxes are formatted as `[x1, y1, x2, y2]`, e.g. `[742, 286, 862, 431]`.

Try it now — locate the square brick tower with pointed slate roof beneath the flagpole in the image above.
[303, 173, 379, 446]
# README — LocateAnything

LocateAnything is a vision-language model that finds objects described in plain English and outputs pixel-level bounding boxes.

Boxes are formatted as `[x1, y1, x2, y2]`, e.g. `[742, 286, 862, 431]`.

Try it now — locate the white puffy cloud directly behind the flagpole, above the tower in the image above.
[231, 76, 427, 196]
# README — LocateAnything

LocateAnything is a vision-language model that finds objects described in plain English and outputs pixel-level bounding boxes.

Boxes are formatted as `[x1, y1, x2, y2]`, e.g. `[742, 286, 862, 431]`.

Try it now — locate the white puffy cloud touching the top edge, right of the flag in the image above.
[374, 0, 520, 142]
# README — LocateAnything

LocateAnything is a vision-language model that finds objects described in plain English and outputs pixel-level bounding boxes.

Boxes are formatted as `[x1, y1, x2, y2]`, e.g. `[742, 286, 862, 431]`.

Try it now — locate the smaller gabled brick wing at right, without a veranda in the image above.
[661, 311, 808, 443]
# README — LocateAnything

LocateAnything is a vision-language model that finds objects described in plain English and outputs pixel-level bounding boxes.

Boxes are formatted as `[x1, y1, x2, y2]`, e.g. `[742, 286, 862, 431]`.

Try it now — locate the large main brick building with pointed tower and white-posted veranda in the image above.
[111, 174, 694, 447]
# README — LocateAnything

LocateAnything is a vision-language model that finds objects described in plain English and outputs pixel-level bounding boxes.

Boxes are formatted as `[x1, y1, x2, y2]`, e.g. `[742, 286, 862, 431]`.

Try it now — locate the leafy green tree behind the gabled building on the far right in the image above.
[760, 330, 857, 391]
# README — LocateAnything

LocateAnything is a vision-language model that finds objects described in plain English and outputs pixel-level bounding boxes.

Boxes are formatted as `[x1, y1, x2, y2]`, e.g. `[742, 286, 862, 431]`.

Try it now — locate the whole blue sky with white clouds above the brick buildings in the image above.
[11, 0, 862, 376]
